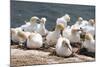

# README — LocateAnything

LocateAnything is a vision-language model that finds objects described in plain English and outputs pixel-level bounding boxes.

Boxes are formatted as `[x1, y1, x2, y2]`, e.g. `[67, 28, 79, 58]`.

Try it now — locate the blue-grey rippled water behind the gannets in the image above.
[10, 0, 95, 30]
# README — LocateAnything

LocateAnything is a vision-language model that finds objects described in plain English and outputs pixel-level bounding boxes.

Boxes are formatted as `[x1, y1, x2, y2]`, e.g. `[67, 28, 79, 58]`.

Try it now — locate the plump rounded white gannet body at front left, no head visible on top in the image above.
[27, 32, 43, 48]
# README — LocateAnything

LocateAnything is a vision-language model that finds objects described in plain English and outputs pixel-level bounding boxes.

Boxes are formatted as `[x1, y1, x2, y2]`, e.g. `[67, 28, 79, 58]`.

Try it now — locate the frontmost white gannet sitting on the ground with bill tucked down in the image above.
[56, 37, 72, 57]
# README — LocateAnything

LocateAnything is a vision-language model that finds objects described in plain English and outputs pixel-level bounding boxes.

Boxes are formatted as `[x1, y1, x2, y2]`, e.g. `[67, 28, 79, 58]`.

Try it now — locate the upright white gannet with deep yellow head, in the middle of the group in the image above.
[46, 23, 64, 45]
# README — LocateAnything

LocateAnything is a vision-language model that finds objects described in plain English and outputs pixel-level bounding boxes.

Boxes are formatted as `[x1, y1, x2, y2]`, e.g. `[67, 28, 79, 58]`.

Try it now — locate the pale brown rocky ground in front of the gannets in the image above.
[10, 45, 95, 67]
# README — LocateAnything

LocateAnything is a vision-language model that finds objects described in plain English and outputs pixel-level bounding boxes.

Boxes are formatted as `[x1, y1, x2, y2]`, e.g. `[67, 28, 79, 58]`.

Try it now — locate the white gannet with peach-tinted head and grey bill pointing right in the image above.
[63, 25, 80, 42]
